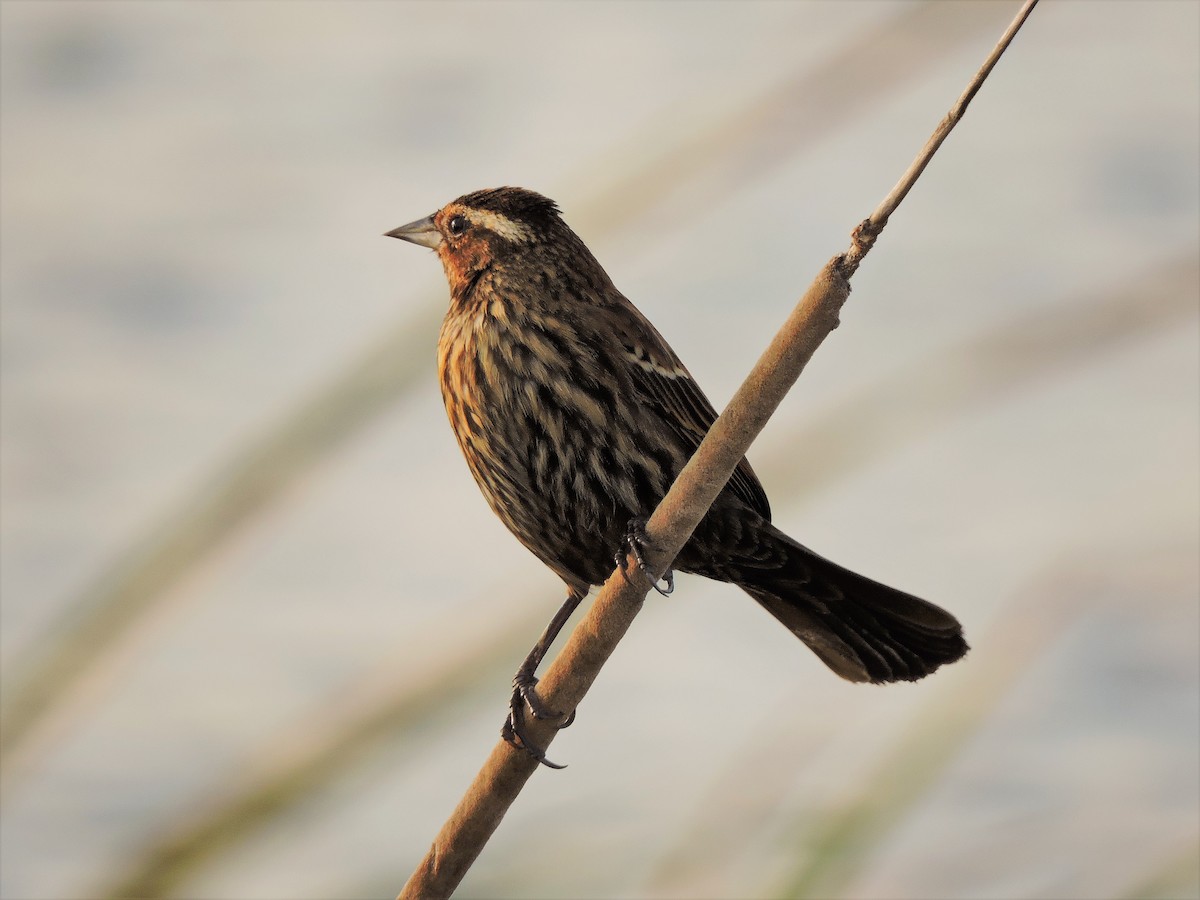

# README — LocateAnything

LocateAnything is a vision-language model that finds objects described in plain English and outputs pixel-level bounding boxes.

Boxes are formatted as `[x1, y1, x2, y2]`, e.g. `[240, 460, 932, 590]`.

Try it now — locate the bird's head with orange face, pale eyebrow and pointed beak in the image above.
[386, 187, 574, 300]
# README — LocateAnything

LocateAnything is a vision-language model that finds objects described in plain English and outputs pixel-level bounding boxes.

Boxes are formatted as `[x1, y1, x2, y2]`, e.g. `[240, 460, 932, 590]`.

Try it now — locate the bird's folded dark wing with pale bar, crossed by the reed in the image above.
[613, 300, 770, 521]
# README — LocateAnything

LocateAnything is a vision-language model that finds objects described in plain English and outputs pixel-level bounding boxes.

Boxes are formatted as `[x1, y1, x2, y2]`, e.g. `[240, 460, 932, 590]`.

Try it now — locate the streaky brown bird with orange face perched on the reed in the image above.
[385, 187, 968, 768]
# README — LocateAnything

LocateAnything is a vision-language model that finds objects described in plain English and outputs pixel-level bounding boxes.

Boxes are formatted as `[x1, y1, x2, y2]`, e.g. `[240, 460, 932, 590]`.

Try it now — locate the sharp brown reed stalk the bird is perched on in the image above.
[398, 0, 1037, 900]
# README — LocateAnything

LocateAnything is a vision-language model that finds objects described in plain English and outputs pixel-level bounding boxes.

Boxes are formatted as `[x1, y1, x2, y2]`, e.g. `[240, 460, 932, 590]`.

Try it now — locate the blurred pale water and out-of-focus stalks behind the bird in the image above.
[0, 0, 1200, 900]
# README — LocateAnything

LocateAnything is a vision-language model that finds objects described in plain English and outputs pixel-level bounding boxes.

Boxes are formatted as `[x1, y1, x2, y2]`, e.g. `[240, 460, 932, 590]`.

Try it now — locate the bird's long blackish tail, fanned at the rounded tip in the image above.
[736, 526, 968, 684]
